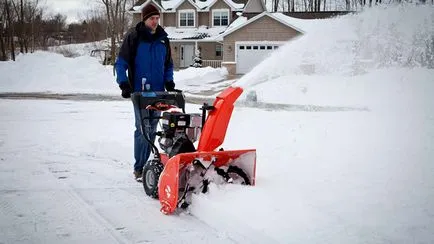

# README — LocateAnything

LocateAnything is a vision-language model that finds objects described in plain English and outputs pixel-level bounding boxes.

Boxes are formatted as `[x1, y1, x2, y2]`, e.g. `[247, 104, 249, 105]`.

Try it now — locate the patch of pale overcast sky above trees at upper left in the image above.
[40, 0, 102, 24]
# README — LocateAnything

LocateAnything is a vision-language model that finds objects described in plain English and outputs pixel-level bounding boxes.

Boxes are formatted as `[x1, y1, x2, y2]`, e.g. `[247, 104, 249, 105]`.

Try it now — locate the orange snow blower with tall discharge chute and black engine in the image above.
[133, 87, 256, 214]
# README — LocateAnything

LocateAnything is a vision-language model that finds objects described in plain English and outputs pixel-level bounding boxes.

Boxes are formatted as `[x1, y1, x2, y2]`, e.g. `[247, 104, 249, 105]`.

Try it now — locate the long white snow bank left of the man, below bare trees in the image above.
[0, 51, 119, 94]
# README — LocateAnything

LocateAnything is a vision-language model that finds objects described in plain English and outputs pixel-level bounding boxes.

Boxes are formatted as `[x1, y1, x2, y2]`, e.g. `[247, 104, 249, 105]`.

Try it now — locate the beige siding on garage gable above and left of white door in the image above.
[223, 15, 300, 62]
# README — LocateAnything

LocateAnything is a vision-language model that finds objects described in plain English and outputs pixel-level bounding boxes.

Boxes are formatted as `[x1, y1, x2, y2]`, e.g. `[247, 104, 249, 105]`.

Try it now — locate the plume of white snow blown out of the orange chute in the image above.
[237, 4, 434, 87]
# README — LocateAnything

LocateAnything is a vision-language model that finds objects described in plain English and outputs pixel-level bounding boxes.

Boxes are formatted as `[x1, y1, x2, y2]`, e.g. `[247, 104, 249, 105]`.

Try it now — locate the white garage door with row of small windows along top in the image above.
[236, 43, 279, 74]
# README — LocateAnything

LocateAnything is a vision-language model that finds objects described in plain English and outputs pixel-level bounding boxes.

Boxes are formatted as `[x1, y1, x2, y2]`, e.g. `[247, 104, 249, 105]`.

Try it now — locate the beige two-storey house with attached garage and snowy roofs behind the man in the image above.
[130, 0, 302, 74]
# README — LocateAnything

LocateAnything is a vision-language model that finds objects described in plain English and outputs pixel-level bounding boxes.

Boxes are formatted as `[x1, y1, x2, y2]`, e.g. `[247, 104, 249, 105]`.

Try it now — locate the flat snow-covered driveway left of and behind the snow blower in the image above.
[0, 100, 237, 243]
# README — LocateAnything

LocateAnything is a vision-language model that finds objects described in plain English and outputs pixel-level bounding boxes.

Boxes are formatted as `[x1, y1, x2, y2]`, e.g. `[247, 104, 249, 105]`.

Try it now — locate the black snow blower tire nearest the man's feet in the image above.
[142, 159, 164, 199]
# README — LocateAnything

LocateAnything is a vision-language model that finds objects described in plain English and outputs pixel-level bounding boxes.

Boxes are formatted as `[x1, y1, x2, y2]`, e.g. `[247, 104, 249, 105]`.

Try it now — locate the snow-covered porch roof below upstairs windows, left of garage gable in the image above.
[164, 26, 226, 41]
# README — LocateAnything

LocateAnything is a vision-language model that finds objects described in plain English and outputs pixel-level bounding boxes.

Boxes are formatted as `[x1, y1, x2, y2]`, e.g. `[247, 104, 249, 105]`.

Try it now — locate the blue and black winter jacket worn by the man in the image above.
[115, 22, 173, 92]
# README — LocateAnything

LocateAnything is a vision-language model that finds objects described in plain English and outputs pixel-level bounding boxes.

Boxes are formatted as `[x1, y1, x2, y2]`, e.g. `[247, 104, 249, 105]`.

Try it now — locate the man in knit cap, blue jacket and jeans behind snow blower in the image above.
[115, 4, 175, 181]
